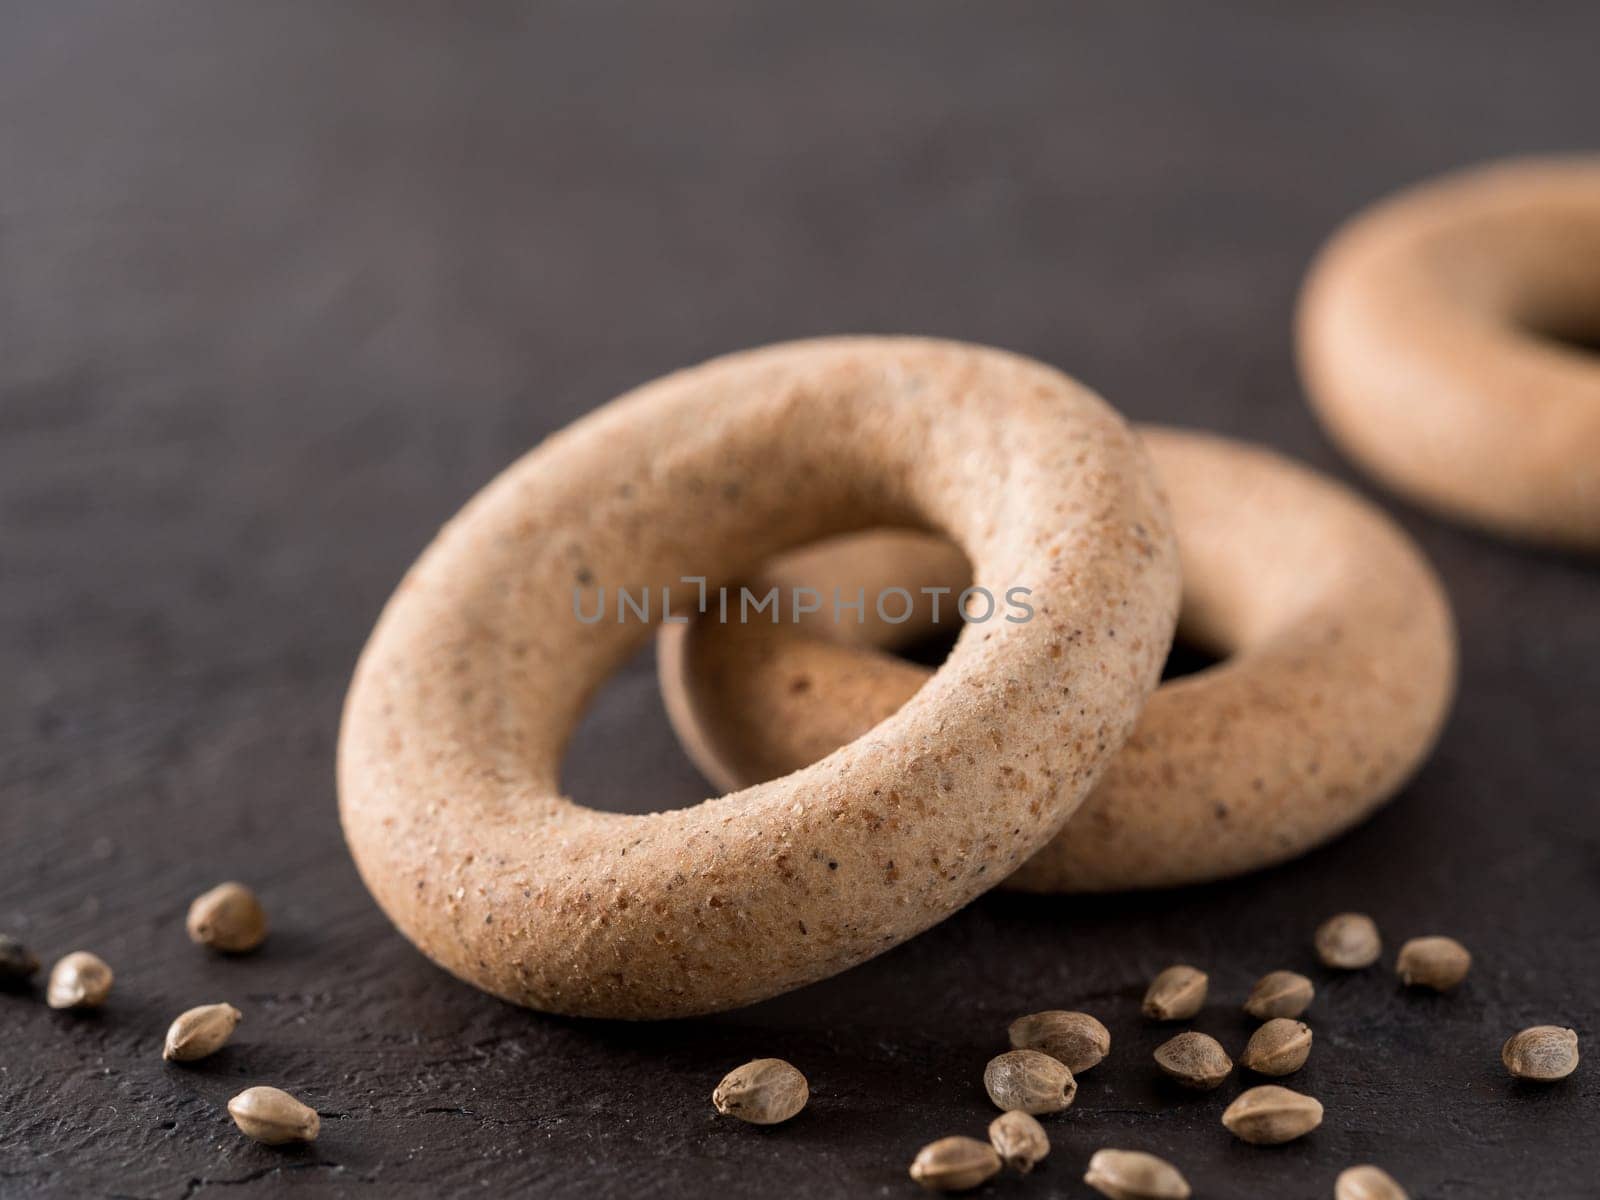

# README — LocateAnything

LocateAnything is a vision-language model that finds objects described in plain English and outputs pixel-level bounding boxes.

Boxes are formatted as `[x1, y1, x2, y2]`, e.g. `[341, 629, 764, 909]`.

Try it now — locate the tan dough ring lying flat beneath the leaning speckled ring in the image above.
[658, 427, 1456, 891]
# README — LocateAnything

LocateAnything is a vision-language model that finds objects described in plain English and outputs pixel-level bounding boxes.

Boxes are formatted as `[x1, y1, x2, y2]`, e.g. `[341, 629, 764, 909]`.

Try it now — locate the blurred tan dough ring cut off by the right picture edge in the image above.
[1298, 157, 1600, 550]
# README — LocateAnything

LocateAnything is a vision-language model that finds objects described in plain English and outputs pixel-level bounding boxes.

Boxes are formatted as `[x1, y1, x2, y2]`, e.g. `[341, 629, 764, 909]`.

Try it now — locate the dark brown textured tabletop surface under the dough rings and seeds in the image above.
[0, 0, 1600, 1197]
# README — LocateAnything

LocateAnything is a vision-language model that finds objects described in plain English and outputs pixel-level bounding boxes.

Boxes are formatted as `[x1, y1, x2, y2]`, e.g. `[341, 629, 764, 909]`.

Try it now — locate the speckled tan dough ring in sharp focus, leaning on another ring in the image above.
[339, 338, 1179, 1018]
